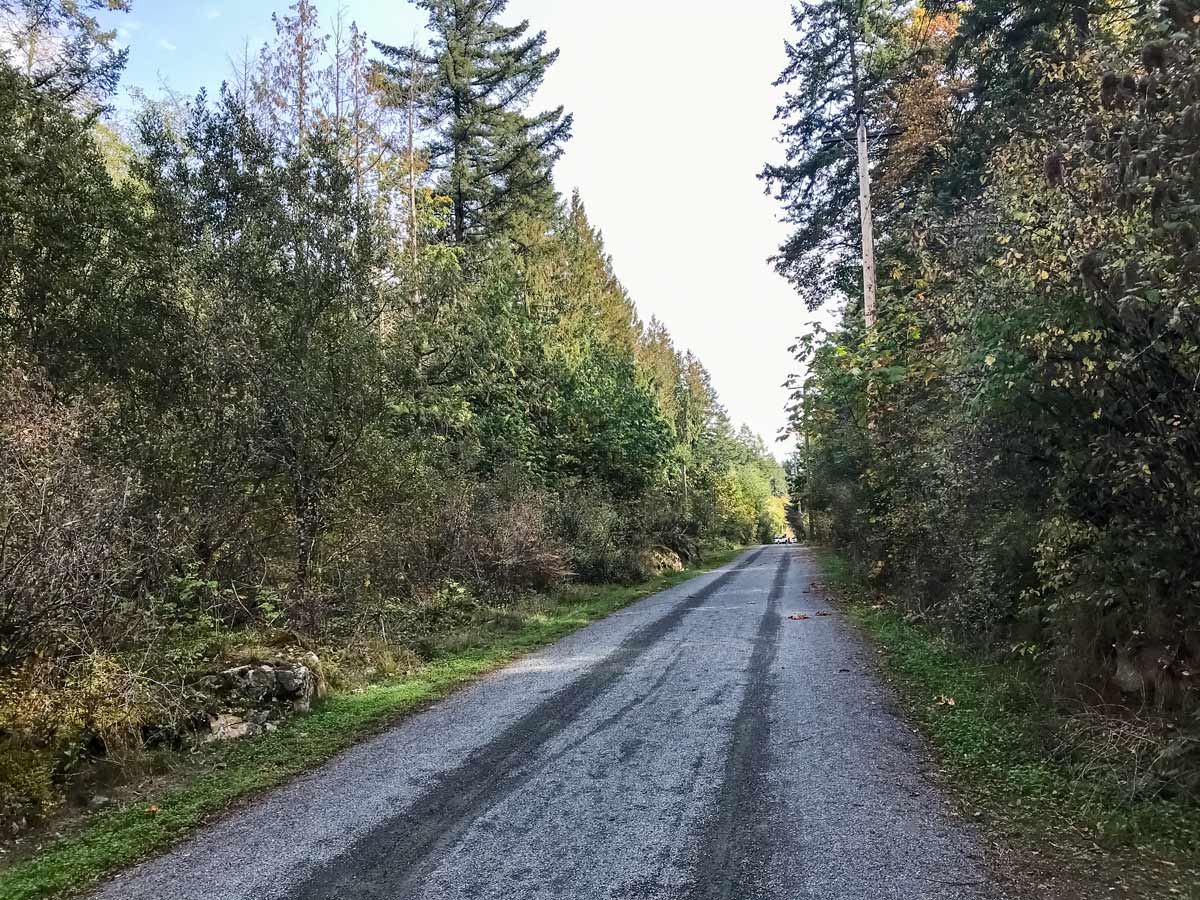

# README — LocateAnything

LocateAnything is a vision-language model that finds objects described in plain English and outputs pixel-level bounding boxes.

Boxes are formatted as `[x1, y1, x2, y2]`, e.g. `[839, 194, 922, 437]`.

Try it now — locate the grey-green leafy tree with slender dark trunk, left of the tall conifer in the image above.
[134, 94, 388, 622]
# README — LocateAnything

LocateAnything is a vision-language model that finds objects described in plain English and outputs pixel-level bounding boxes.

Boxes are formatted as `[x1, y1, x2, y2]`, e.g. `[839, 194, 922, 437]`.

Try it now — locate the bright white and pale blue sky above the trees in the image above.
[108, 0, 812, 456]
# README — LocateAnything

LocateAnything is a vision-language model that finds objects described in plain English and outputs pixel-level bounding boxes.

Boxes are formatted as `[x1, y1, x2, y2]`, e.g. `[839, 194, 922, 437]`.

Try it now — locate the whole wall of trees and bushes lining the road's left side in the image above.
[0, 0, 785, 849]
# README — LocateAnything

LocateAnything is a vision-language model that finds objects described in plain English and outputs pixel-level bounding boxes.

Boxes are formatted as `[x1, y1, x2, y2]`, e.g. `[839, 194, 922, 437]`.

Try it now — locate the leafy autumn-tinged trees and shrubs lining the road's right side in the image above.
[777, 2, 1200, 798]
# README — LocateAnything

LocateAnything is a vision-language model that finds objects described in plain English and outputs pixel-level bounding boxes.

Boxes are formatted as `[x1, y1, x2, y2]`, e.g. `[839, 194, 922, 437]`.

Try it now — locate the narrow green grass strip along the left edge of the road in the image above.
[0, 550, 740, 900]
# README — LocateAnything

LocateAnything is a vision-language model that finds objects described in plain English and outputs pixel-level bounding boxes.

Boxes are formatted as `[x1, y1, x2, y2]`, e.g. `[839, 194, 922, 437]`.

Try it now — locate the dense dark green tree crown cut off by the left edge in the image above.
[0, 65, 173, 391]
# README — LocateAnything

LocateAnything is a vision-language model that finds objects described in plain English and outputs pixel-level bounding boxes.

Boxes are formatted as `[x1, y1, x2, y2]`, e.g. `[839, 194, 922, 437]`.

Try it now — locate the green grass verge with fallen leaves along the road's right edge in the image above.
[822, 552, 1200, 900]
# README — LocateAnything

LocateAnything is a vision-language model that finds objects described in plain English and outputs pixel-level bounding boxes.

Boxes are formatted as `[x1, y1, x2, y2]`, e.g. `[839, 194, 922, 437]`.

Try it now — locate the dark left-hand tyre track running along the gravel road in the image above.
[287, 550, 763, 900]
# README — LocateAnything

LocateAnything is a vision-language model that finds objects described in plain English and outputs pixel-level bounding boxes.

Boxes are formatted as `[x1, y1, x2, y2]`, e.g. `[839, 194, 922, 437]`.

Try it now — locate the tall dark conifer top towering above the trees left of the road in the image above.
[377, 0, 571, 244]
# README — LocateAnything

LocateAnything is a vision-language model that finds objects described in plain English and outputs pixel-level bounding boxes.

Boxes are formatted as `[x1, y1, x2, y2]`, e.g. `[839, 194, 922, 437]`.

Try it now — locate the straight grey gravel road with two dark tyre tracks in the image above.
[98, 546, 1000, 900]
